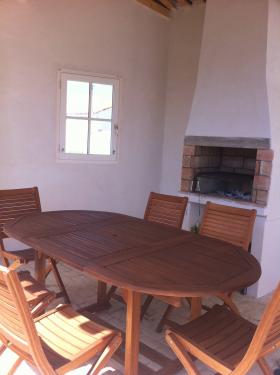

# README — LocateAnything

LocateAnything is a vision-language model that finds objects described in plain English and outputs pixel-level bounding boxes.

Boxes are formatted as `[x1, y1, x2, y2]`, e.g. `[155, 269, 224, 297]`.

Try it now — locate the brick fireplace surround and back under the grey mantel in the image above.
[181, 145, 273, 206]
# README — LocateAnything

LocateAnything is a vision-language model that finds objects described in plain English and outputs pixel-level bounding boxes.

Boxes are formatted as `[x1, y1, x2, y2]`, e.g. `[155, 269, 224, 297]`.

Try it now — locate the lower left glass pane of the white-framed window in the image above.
[65, 119, 88, 154]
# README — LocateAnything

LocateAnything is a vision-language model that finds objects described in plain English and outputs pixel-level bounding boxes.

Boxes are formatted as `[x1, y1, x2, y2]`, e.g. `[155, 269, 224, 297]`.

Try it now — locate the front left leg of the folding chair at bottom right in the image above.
[165, 331, 200, 375]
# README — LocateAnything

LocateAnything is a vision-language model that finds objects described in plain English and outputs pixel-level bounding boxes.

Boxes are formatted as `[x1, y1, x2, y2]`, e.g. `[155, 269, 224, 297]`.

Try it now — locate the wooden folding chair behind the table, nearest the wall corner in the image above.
[108, 192, 188, 331]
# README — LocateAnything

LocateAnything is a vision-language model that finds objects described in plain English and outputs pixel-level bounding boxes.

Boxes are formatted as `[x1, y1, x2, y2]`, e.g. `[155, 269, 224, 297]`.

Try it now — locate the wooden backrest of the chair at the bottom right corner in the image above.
[232, 283, 280, 375]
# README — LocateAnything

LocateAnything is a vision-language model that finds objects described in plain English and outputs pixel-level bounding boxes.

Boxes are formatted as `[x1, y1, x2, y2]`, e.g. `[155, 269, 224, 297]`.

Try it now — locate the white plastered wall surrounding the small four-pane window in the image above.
[0, 0, 169, 222]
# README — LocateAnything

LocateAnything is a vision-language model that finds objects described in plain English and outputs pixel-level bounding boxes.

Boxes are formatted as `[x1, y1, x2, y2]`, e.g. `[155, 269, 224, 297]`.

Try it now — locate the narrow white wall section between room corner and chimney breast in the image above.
[161, 4, 205, 194]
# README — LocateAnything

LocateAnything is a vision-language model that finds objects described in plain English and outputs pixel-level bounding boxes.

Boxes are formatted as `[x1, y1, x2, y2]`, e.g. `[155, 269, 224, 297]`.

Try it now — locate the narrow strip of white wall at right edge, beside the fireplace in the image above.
[258, 0, 280, 296]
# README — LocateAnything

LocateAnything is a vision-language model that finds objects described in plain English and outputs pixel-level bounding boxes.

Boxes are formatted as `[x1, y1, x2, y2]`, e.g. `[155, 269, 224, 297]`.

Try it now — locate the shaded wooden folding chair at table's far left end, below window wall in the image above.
[0, 187, 70, 303]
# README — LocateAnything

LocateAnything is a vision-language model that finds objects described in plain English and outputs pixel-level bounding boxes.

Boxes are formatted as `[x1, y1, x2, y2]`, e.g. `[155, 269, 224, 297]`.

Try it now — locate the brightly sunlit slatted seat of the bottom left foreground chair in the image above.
[36, 305, 120, 373]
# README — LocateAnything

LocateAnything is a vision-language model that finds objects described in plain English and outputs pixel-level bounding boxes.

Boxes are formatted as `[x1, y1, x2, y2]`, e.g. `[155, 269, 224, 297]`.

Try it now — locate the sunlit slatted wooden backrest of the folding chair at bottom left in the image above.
[0, 266, 55, 374]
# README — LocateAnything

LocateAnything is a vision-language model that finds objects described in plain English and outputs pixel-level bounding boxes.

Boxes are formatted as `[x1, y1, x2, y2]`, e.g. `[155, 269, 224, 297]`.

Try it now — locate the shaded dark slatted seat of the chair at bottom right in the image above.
[173, 305, 256, 370]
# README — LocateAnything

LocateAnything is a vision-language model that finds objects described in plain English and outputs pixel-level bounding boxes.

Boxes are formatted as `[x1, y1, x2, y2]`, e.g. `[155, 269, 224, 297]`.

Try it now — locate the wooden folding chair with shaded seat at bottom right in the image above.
[166, 283, 280, 375]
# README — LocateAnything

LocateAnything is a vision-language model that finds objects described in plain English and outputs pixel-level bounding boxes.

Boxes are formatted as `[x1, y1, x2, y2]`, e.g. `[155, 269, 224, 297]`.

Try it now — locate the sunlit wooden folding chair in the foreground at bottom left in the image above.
[0, 266, 122, 375]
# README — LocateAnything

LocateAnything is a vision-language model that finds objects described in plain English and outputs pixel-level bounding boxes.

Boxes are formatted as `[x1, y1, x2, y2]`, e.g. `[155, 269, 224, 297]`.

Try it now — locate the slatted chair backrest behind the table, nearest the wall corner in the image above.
[144, 192, 188, 229]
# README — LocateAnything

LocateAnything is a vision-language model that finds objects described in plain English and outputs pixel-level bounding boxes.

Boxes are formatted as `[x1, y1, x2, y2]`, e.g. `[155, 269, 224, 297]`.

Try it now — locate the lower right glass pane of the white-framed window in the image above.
[90, 121, 111, 155]
